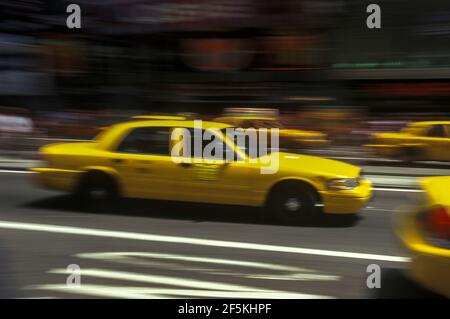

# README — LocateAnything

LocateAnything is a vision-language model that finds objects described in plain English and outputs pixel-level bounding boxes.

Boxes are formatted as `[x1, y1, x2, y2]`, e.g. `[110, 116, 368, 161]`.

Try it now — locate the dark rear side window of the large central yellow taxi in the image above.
[117, 127, 170, 156]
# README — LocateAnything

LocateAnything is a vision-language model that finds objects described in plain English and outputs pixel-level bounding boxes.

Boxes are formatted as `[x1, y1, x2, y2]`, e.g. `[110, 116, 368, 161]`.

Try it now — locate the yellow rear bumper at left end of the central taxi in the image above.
[30, 168, 81, 192]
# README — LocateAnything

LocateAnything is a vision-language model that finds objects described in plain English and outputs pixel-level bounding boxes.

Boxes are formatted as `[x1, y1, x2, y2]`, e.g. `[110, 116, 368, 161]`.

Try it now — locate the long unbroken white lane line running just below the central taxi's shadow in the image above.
[0, 221, 410, 262]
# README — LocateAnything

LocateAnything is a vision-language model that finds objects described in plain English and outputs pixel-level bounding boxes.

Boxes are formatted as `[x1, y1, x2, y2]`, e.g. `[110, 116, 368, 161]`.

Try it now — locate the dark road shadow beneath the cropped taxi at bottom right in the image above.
[366, 268, 445, 299]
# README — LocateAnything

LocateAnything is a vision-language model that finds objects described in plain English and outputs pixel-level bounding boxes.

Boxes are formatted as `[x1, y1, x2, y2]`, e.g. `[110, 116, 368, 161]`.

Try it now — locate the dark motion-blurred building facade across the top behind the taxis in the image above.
[0, 0, 450, 113]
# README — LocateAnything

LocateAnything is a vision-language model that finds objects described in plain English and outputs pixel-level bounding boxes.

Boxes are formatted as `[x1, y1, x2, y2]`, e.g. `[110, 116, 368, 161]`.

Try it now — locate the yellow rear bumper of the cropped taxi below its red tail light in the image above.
[395, 208, 450, 298]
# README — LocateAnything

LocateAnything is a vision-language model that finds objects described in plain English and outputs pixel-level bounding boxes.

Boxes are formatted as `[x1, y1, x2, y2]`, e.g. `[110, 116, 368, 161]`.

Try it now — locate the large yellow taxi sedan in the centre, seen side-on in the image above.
[32, 120, 371, 222]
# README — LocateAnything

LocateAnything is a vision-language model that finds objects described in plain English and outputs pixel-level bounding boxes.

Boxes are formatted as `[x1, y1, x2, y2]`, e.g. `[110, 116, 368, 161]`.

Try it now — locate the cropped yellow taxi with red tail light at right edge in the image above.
[395, 176, 450, 298]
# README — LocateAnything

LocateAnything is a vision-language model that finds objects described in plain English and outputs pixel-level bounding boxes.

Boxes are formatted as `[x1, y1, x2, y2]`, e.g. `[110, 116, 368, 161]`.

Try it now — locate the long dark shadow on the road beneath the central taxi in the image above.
[23, 195, 362, 228]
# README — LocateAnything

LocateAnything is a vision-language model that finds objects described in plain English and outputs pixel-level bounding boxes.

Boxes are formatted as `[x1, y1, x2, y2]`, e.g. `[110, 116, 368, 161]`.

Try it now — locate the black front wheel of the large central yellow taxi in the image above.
[267, 182, 321, 224]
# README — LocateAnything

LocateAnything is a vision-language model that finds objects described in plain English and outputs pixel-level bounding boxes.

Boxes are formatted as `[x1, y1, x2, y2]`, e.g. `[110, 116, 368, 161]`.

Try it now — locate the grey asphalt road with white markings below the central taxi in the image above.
[0, 172, 442, 298]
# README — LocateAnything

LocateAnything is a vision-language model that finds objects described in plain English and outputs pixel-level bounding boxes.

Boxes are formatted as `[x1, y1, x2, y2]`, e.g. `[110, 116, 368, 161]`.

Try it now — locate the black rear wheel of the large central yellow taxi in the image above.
[77, 171, 119, 208]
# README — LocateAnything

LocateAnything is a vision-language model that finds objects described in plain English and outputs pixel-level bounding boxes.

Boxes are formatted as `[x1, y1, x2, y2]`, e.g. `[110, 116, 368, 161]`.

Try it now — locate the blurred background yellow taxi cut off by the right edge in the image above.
[365, 121, 450, 161]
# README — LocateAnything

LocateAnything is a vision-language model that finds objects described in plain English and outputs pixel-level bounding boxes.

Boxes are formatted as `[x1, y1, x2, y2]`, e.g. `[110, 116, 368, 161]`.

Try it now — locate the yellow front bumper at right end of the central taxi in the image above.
[321, 180, 372, 214]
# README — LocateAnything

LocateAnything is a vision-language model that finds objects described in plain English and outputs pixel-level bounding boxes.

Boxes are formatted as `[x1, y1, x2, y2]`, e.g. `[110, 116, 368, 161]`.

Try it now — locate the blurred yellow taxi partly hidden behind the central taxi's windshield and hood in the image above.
[213, 116, 329, 149]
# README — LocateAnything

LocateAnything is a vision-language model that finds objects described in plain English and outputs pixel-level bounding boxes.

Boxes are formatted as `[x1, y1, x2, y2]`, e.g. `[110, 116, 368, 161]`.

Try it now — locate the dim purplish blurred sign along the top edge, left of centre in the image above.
[87, 0, 265, 33]
